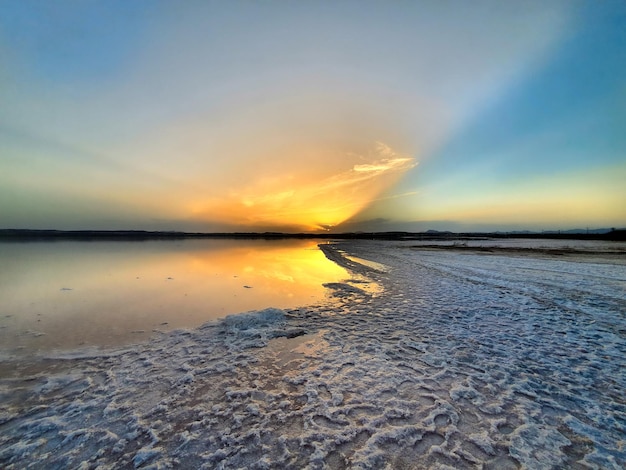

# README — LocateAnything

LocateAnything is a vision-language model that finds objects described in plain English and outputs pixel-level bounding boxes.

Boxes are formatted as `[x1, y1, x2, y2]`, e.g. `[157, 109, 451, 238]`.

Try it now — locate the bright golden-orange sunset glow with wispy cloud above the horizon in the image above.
[192, 142, 415, 230]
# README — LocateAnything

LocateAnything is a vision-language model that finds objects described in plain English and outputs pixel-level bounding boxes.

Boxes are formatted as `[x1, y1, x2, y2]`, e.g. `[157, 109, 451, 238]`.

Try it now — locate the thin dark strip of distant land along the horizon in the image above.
[0, 229, 626, 241]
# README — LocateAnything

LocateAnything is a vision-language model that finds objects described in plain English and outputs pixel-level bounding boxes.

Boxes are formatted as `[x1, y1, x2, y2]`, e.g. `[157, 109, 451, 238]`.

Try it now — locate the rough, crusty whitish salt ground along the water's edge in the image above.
[0, 242, 626, 469]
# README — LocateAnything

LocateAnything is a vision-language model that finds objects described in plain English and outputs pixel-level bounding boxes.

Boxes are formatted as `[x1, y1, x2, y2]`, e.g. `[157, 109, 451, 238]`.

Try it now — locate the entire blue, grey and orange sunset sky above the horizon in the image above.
[0, 0, 626, 232]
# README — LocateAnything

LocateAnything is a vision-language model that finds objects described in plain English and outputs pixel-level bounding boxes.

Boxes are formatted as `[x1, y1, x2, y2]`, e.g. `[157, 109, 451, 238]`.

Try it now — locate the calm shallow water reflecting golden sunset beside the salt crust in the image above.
[0, 240, 349, 351]
